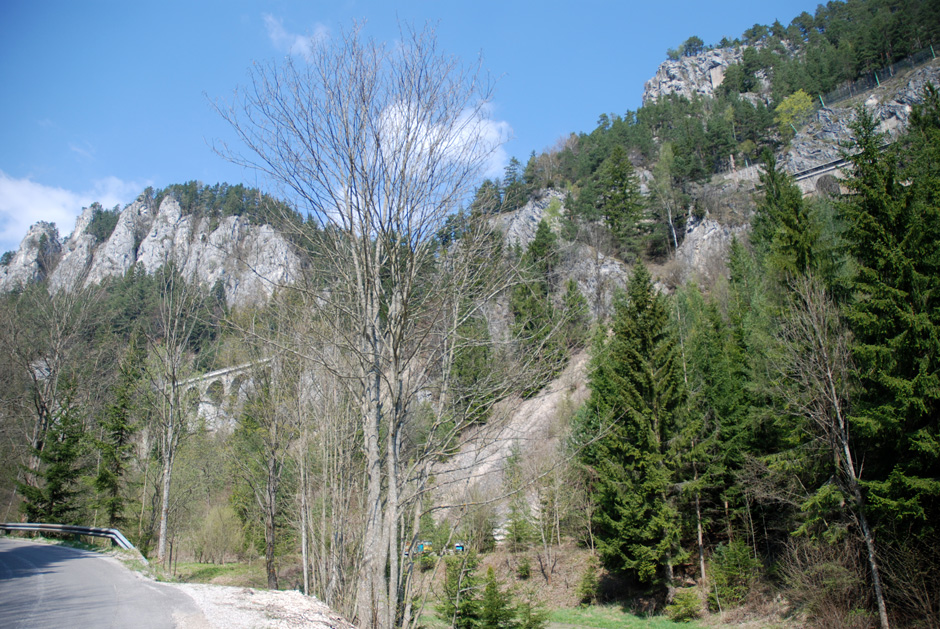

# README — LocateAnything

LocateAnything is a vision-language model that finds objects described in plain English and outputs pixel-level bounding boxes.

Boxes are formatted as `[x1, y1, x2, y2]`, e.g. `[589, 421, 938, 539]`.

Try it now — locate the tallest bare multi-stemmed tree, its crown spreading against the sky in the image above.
[220, 24, 516, 627]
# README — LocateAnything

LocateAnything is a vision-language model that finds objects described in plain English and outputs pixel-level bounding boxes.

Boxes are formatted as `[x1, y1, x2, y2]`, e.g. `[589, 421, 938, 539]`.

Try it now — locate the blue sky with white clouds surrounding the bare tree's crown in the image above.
[0, 0, 816, 251]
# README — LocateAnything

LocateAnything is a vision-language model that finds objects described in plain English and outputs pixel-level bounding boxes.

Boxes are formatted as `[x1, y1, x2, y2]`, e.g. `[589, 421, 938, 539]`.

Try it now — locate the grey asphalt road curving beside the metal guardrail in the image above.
[0, 537, 205, 629]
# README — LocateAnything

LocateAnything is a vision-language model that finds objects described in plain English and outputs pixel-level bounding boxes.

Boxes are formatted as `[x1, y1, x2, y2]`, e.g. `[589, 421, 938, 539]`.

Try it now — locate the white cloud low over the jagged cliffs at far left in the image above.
[0, 171, 148, 251]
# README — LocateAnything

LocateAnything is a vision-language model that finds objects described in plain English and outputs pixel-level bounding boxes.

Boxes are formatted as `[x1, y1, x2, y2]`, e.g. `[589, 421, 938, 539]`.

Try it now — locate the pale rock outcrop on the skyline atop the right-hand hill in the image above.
[643, 46, 745, 105]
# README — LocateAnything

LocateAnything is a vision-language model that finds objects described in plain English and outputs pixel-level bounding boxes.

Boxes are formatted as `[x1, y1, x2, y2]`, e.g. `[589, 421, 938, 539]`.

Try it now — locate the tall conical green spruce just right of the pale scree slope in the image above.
[583, 264, 686, 586]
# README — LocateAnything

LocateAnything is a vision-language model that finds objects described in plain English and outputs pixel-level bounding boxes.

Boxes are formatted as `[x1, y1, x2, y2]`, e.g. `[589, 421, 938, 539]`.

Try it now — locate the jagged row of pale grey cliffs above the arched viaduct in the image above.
[0, 197, 299, 308]
